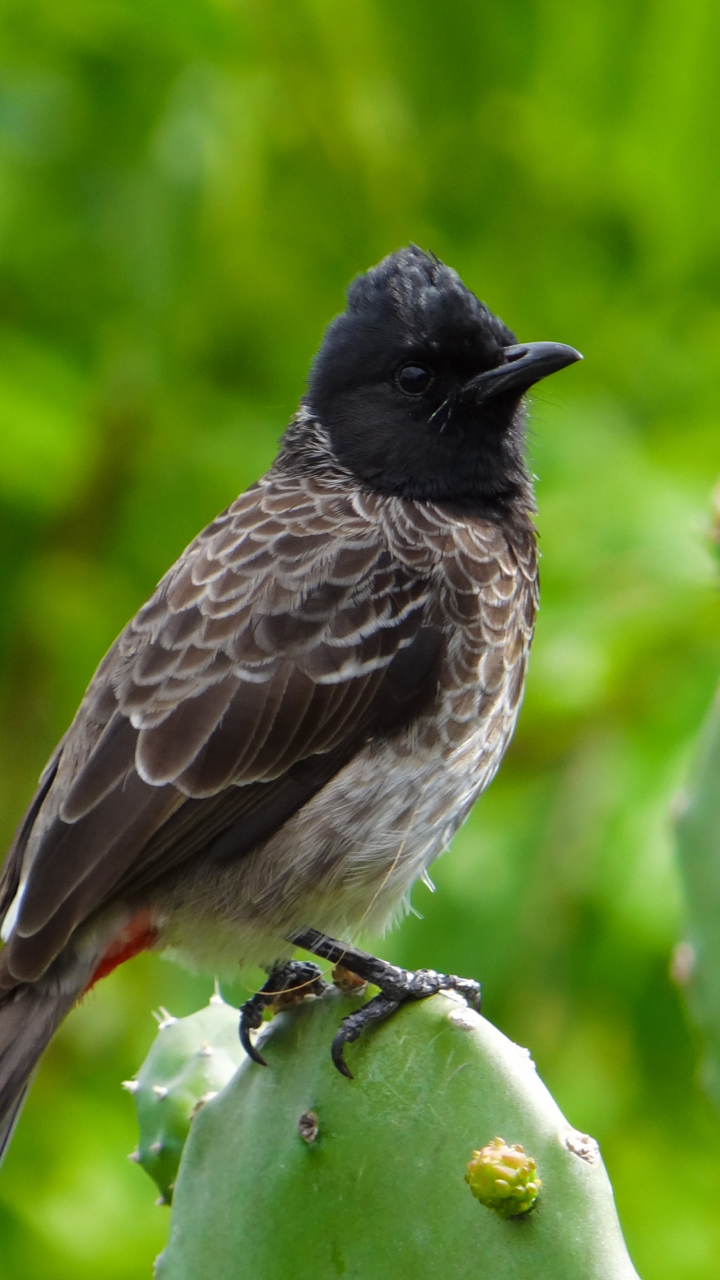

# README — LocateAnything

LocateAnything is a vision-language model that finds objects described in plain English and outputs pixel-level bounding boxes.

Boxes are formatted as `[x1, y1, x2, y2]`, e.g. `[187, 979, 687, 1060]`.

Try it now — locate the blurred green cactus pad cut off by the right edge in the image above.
[673, 698, 720, 1107]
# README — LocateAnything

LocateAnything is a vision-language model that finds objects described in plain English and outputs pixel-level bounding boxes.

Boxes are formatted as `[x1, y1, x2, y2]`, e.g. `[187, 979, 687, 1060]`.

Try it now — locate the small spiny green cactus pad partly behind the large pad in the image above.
[123, 992, 245, 1204]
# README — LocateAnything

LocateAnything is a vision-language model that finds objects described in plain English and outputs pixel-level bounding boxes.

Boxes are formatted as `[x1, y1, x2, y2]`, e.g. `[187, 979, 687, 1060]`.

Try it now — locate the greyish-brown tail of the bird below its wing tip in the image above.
[0, 983, 82, 1164]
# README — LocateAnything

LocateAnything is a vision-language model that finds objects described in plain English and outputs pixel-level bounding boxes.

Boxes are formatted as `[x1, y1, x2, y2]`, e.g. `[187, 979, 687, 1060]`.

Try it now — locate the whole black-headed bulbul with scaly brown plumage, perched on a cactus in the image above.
[0, 246, 580, 1157]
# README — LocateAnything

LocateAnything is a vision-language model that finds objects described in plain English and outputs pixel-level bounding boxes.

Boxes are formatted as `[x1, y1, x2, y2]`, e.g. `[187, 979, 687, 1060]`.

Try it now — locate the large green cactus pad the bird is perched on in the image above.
[135, 991, 637, 1280]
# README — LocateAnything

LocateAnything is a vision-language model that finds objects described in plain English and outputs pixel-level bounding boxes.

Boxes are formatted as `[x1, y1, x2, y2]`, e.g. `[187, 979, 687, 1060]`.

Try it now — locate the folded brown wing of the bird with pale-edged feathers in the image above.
[3, 474, 441, 980]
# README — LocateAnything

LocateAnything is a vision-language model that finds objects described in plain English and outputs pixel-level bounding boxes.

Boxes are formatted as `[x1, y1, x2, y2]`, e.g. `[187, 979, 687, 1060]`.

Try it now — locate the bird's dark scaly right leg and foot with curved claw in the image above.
[288, 929, 480, 1080]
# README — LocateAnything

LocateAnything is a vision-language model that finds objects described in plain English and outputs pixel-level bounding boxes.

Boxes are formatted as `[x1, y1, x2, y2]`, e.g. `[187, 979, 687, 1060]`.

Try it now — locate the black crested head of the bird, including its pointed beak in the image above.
[306, 246, 580, 508]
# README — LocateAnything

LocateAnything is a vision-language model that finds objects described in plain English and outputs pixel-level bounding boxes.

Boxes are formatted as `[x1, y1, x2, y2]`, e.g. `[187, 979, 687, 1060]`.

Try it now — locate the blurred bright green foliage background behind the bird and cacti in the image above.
[0, 0, 720, 1280]
